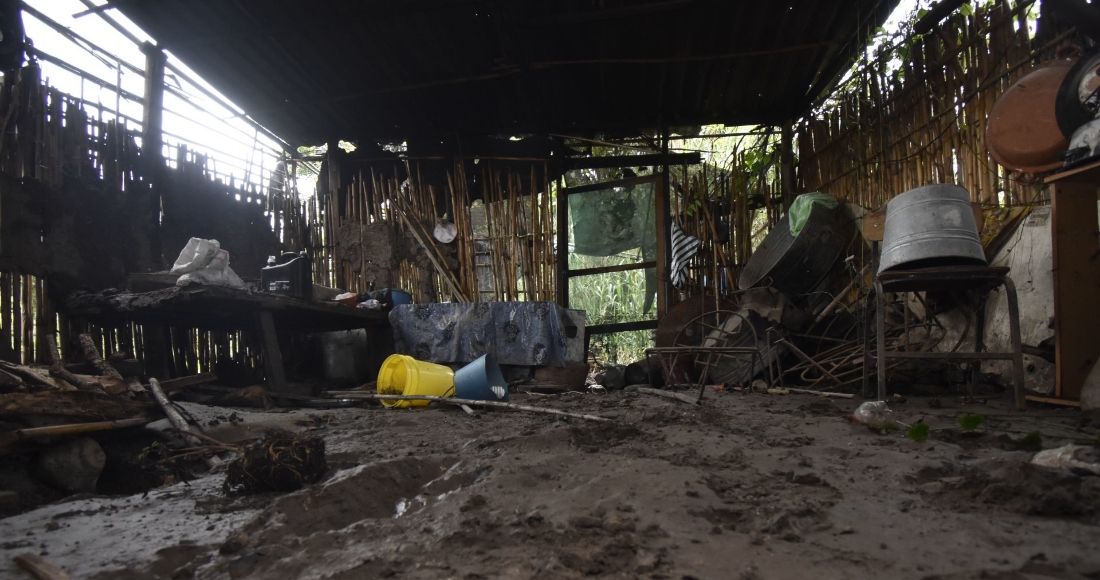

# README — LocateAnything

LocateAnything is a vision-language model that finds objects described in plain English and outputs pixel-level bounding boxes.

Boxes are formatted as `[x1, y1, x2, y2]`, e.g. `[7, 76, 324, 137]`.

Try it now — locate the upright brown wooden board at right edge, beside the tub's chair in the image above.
[1051, 180, 1100, 400]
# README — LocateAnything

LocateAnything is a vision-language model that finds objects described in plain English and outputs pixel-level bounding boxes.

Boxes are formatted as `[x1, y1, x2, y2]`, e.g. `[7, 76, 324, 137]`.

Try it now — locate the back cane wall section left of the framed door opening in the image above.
[316, 157, 556, 303]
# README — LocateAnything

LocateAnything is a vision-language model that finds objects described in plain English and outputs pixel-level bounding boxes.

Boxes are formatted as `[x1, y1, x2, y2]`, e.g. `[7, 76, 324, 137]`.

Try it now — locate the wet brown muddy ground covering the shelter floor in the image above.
[0, 392, 1100, 580]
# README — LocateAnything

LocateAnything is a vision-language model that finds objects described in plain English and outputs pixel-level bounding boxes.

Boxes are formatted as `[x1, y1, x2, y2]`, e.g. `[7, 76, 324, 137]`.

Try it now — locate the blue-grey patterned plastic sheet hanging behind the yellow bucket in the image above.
[389, 302, 565, 366]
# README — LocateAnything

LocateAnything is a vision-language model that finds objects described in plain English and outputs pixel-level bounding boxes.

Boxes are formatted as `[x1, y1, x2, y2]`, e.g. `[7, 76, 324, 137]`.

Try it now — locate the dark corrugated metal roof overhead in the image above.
[112, 0, 898, 143]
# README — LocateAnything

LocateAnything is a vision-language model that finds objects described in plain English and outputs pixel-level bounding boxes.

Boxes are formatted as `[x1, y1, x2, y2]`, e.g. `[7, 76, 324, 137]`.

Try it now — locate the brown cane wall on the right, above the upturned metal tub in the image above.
[798, 0, 1051, 208]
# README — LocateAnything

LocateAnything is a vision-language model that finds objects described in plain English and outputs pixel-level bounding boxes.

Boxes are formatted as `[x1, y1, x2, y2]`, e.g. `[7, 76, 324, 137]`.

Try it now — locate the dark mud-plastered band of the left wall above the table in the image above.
[0, 162, 278, 298]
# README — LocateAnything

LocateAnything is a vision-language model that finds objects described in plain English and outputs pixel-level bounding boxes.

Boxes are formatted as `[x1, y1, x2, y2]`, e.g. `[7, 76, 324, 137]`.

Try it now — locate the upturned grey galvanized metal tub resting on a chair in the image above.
[879, 184, 988, 273]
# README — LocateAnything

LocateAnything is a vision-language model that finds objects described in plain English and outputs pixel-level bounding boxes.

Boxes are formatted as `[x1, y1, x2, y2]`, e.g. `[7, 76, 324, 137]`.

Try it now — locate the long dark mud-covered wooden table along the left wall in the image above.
[65, 284, 389, 393]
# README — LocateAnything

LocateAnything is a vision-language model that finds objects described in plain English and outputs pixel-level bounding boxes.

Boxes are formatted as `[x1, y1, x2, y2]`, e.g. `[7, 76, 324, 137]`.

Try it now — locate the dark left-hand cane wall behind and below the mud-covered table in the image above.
[0, 66, 283, 380]
